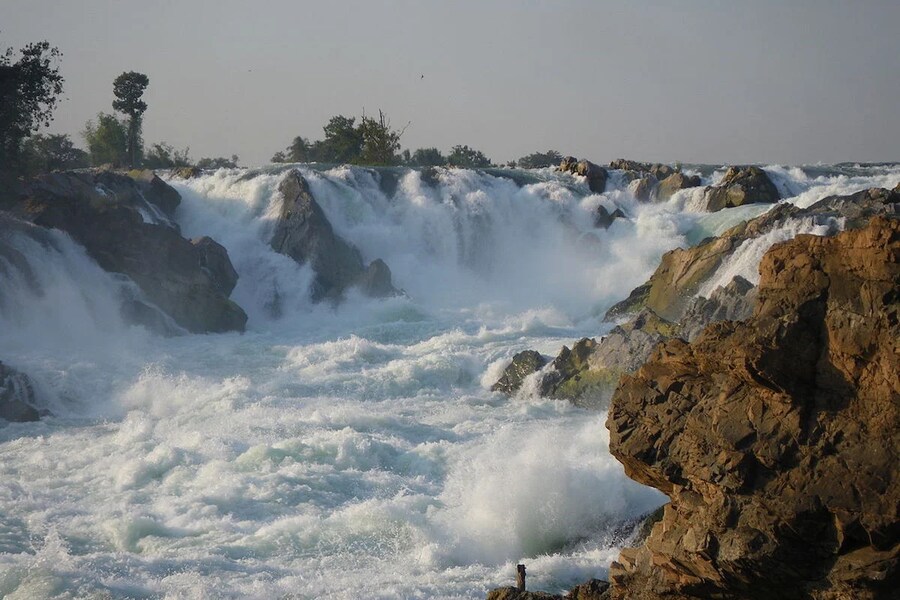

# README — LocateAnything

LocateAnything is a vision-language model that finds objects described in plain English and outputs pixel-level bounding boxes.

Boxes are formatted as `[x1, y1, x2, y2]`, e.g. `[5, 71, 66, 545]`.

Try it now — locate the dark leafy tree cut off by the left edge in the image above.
[0, 41, 63, 166]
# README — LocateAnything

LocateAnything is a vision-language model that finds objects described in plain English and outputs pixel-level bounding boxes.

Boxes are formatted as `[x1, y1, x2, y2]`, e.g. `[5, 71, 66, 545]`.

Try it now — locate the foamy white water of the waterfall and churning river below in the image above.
[0, 162, 897, 599]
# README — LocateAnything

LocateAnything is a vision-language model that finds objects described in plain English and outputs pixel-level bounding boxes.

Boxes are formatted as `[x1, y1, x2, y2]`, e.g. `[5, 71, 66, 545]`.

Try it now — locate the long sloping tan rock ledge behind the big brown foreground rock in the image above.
[604, 188, 900, 322]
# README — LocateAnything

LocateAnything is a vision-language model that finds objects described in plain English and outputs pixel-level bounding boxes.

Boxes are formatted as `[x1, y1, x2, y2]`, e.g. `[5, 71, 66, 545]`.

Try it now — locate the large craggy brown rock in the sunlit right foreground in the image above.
[607, 217, 900, 600]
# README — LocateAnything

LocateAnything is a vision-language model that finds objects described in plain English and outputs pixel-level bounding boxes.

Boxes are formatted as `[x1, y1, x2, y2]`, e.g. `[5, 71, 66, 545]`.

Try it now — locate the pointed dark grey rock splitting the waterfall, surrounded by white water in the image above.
[271, 169, 399, 302]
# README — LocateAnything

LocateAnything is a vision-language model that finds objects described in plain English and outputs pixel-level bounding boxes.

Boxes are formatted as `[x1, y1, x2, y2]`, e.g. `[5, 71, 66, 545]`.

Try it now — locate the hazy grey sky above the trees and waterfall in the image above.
[0, 0, 900, 166]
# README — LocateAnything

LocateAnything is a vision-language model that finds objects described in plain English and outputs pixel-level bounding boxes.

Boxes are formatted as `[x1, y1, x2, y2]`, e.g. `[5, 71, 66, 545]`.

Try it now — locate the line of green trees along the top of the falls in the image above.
[0, 41, 562, 175]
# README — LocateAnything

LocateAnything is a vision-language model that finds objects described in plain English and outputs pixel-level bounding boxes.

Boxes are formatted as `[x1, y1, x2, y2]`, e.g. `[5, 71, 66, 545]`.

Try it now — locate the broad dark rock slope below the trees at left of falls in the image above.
[0, 171, 247, 333]
